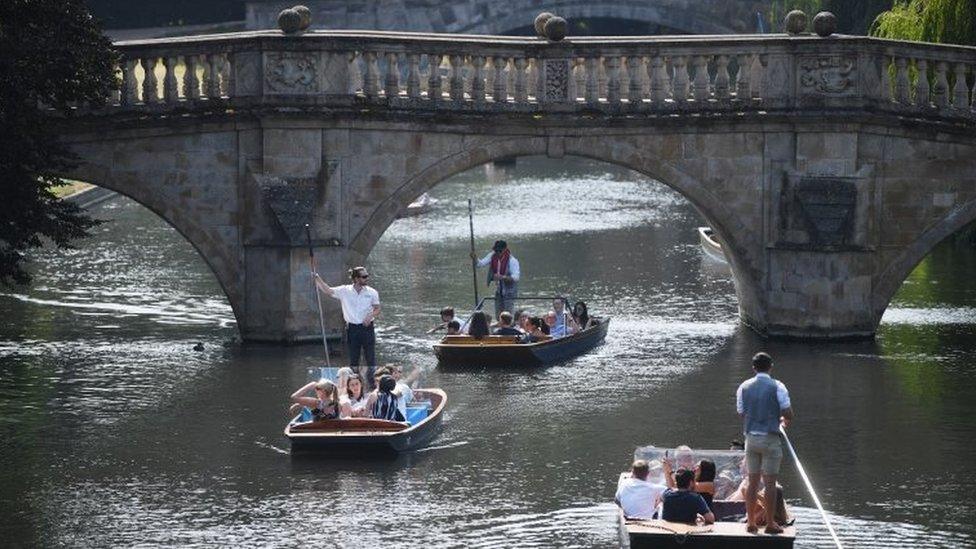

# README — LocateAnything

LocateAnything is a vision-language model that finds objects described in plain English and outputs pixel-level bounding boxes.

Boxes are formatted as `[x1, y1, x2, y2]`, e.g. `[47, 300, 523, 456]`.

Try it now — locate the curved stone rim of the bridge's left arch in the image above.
[53, 163, 243, 326]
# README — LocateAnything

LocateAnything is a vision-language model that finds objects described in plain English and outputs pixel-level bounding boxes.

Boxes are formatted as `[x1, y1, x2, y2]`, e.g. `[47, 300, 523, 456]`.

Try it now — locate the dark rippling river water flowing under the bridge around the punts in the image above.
[0, 158, 976, 547]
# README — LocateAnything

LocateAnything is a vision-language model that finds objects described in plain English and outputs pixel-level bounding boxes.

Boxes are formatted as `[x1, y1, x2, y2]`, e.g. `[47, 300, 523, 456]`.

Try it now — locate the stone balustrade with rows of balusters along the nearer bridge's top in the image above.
[78, 31, 976, 121]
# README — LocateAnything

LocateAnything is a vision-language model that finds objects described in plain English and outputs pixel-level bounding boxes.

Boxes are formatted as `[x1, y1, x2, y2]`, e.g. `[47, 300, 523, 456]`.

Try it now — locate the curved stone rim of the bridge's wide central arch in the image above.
[349, 132, 763, 322]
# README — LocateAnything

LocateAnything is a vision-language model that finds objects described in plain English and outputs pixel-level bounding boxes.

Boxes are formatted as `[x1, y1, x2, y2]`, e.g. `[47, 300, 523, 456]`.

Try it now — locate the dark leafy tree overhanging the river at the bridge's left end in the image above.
[0, 0, 117, 284]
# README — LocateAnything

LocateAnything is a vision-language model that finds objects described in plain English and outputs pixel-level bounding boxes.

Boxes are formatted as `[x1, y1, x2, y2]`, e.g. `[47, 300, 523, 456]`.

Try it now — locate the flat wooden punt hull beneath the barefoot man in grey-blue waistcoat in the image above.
[617, 508, 796, 549]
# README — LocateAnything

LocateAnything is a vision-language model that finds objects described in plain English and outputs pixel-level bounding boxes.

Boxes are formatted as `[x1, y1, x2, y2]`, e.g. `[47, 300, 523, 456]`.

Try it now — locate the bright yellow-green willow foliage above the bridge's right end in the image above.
[871, 0, 976, 46]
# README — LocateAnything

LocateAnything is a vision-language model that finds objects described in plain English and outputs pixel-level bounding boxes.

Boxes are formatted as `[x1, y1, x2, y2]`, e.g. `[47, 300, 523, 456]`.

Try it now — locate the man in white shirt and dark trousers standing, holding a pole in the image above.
[315, 267, 380, 383]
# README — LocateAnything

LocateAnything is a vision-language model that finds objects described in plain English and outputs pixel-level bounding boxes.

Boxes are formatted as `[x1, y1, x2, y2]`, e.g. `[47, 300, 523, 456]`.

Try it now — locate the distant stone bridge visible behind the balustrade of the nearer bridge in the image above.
[246, 0, 778, 34]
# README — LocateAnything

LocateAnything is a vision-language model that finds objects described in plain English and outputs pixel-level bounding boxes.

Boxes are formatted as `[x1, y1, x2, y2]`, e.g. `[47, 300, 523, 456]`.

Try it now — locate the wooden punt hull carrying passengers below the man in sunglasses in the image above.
[285, 389, 447, 456]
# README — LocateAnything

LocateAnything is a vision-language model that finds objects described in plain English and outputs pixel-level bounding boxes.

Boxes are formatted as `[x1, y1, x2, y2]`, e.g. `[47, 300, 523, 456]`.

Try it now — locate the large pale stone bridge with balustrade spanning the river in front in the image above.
[56, 31, 976, 341]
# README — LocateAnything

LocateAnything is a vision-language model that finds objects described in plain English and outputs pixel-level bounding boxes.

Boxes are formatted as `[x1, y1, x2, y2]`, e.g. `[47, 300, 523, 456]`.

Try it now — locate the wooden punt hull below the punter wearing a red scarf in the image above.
[434, 317, 610, 367]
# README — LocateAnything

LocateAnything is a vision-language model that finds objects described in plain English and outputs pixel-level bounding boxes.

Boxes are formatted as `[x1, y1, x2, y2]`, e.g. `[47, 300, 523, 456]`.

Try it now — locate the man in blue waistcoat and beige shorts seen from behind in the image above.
[735, 353, 793, 534]
